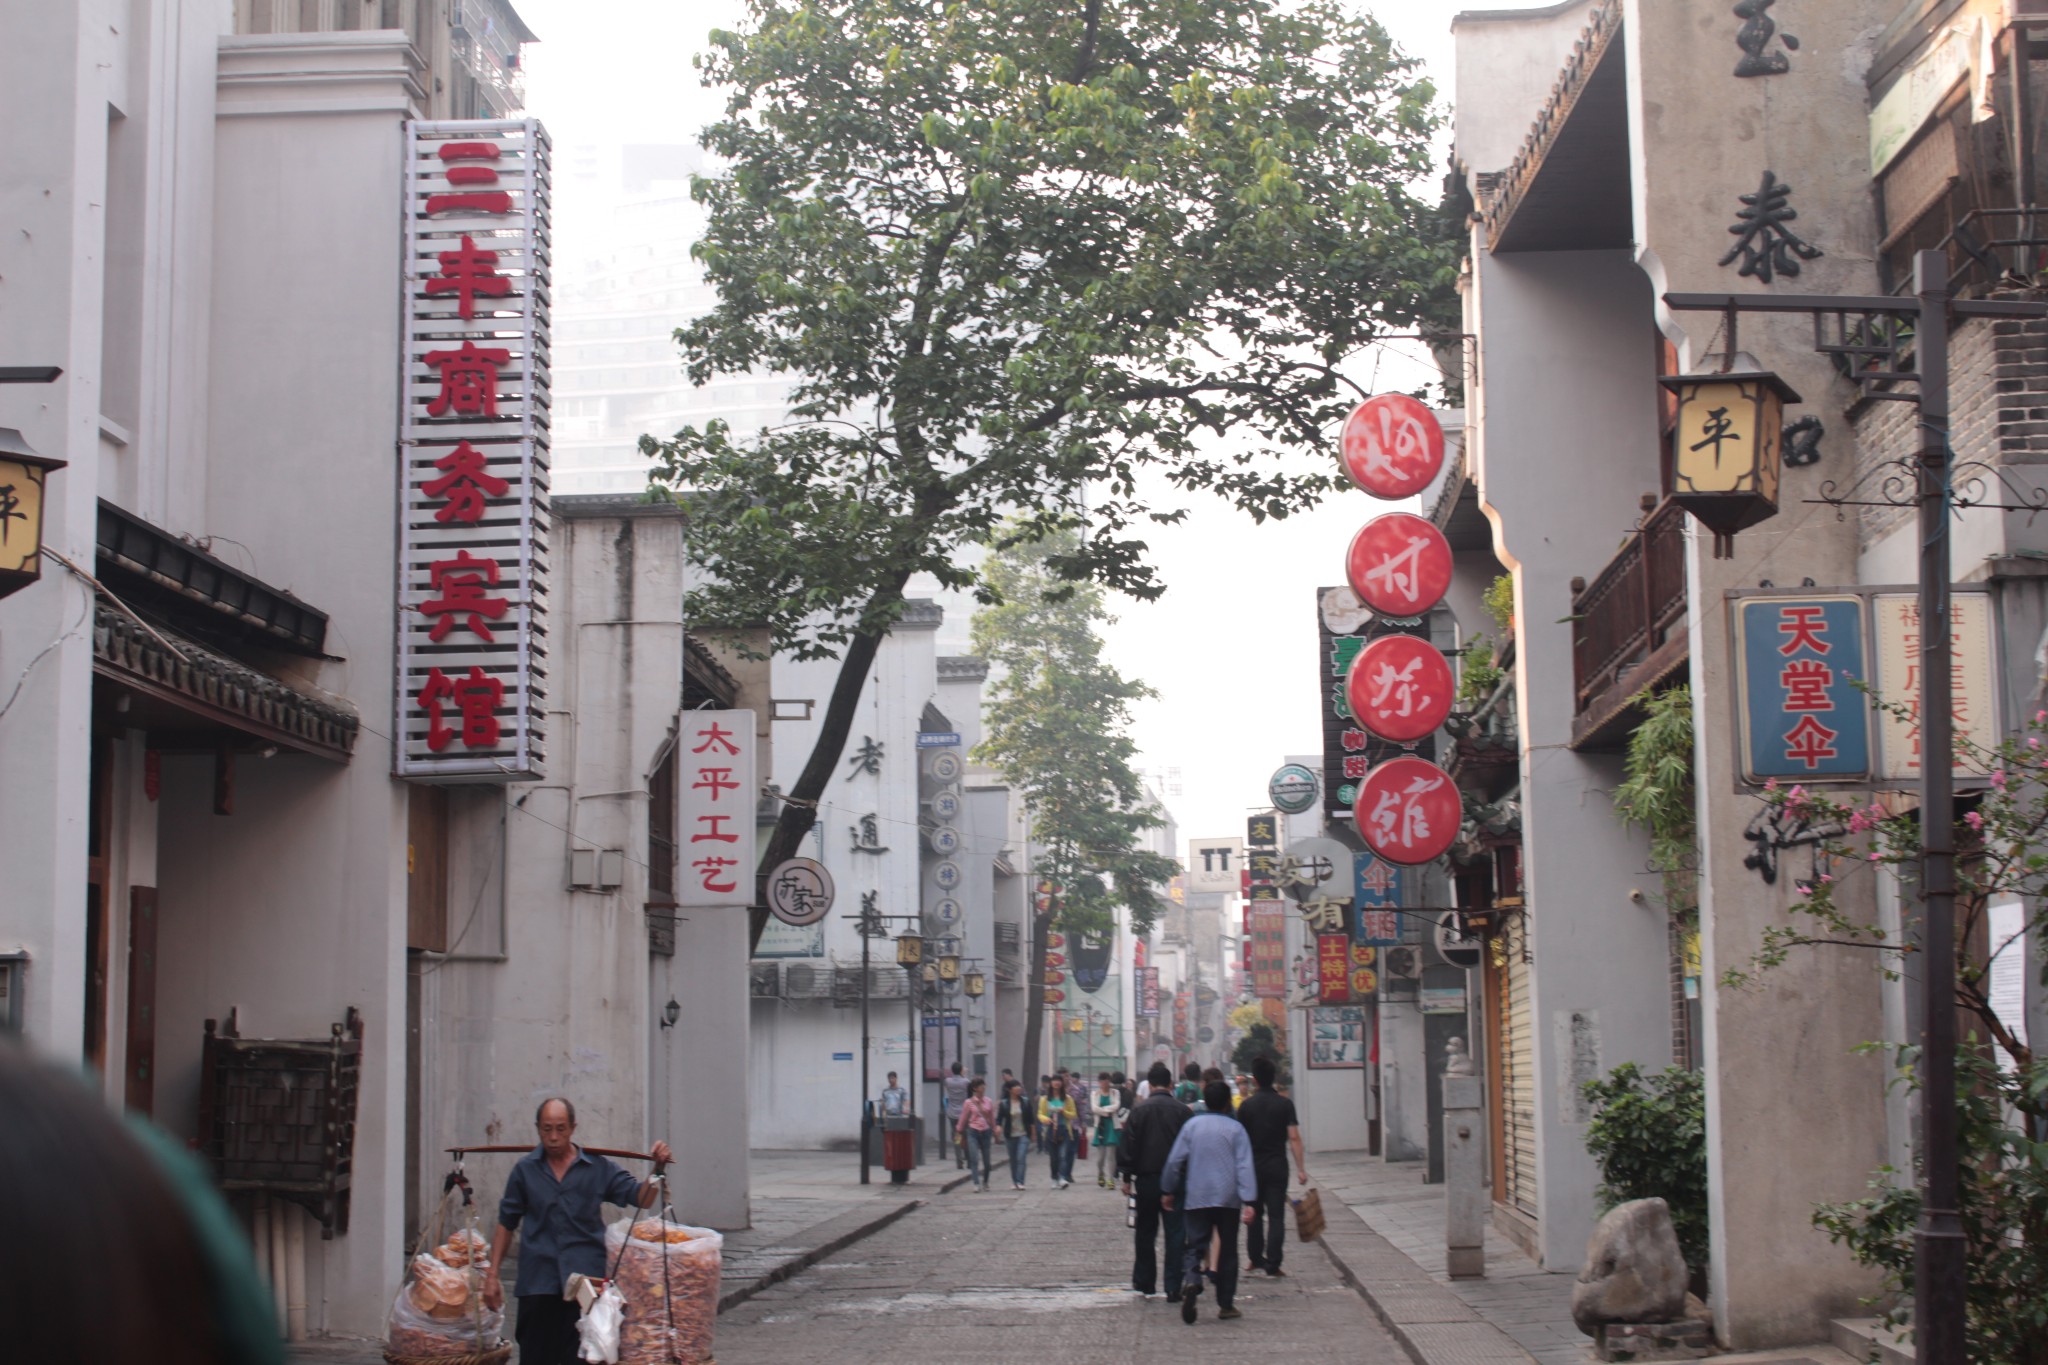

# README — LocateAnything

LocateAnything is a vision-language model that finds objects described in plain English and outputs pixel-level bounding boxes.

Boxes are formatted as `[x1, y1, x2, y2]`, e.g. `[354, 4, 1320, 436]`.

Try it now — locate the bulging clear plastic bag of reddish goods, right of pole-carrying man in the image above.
[604, 1212, 725, 1365]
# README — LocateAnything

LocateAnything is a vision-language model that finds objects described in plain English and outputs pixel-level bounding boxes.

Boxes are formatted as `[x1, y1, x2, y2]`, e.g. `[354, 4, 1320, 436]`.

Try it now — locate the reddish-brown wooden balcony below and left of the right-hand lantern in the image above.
[1571, 497, 1690, 751]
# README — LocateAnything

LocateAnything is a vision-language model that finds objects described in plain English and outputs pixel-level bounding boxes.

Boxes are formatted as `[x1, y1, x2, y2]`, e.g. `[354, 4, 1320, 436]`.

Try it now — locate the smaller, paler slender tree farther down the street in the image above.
[975, 532, 1180, 1074]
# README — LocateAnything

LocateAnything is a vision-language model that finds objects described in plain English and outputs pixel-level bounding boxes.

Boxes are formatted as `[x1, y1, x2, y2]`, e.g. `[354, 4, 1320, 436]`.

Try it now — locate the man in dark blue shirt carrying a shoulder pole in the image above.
[483, 1097, 672, 1365]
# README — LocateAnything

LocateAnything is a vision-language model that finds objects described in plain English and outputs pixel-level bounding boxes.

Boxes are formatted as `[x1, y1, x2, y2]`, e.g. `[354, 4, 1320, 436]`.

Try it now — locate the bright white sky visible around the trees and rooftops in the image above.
[514, 0, 1548, 841]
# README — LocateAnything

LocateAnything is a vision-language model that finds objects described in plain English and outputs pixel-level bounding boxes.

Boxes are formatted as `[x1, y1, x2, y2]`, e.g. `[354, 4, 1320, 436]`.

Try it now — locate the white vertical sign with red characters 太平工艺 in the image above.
[676, 710, 760, 907]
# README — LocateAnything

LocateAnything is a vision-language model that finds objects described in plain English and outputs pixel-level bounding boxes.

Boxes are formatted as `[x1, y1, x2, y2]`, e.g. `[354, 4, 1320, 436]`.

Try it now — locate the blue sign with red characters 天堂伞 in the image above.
[1735, 596, 1870, 782]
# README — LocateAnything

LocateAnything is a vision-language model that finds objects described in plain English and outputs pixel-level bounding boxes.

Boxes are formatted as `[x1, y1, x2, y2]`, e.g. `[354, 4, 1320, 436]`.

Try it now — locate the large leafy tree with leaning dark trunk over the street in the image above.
[641, 0, 1460, 937]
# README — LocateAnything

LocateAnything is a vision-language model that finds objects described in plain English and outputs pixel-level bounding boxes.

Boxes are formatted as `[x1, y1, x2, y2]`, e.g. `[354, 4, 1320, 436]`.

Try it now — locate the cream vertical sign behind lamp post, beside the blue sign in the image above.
[1870, 591, 1999, 782]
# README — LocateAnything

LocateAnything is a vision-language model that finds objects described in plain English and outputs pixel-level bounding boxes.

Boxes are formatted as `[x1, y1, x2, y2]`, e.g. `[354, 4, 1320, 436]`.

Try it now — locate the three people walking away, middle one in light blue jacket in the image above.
[1116, 1058, 1309, 1324]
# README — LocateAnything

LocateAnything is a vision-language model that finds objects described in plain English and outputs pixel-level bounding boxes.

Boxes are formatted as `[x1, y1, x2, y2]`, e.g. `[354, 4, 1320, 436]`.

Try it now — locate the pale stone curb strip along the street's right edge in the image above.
[1317, 1199, 1536, 1365]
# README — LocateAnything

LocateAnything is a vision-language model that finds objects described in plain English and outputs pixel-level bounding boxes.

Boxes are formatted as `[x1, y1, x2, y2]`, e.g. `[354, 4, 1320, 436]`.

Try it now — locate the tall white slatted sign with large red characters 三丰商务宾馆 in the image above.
[395, 119, 551, 782]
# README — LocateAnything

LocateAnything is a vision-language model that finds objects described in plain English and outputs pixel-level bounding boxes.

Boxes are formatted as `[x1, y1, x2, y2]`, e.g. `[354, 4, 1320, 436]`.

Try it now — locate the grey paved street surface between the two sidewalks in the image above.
[717, 1154, 1407, 1365]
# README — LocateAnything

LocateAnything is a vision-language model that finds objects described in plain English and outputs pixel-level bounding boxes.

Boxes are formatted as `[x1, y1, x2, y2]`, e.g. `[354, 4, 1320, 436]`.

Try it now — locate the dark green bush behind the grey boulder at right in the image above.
[1581, 1062, 1708, 1269]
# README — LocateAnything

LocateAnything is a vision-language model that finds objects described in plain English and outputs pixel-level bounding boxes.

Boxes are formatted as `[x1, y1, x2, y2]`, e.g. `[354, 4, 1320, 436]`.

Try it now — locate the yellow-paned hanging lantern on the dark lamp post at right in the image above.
[1657, 370, 1800, 559]
